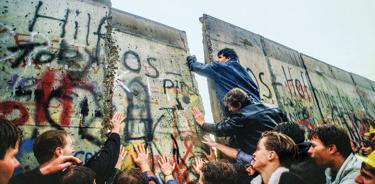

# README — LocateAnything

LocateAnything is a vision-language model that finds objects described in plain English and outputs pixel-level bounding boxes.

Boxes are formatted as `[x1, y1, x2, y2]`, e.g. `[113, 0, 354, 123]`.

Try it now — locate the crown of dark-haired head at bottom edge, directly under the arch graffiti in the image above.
[113, 168, 148, 184]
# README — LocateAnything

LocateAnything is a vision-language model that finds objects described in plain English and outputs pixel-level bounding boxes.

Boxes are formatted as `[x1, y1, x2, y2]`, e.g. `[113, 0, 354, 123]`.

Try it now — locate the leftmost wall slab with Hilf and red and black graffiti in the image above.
[0, 0, 110, 172]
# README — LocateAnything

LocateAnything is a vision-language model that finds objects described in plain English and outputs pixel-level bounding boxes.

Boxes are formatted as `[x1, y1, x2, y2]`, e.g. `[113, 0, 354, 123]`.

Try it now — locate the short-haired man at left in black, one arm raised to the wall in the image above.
[12, 113, 125, 184]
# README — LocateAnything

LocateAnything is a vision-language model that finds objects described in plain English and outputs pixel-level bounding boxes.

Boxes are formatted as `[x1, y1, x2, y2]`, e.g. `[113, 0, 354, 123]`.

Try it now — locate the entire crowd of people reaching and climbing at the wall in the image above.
[0, 48, 375, 184]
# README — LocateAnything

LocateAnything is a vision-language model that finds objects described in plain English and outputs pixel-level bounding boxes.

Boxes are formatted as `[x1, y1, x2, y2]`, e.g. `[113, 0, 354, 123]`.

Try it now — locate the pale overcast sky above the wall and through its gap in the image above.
[112, 0, 375, 122]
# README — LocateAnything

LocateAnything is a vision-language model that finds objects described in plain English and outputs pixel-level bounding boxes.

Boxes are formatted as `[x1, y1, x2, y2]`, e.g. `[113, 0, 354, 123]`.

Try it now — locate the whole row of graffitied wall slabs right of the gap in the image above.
[200, 15, 375, 141]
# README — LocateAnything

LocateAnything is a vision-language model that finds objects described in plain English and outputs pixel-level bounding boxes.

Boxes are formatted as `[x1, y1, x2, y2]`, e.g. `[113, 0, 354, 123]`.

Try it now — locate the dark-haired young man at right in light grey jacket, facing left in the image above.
[308, 125, 361, 184]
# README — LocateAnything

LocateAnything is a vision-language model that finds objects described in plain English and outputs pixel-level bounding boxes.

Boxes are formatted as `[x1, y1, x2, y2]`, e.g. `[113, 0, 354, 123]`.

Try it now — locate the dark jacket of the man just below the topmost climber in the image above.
[202, 103, 288, 154]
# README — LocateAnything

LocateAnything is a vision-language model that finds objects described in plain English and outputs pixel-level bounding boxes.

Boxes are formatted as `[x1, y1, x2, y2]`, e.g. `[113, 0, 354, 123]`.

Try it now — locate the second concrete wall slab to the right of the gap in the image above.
[263, 38, 322, 127]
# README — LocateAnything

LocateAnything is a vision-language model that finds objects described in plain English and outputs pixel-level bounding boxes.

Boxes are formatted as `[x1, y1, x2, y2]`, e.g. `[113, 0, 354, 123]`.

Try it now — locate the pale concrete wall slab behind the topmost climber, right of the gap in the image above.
[201, 15, 277, 122]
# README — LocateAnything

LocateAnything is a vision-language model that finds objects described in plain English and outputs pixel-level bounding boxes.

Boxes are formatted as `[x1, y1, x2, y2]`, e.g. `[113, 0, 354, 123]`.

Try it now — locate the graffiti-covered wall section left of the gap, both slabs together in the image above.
[0, 0, 202, 182]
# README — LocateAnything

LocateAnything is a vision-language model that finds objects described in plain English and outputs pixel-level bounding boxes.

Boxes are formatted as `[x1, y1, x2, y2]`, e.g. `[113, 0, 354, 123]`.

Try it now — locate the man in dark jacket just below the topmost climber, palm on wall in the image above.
[193, 88, 288, 159]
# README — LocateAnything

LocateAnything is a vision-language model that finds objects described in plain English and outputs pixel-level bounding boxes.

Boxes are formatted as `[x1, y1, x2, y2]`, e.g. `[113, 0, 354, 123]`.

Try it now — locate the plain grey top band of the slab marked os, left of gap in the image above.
[111, 8, 188, 51]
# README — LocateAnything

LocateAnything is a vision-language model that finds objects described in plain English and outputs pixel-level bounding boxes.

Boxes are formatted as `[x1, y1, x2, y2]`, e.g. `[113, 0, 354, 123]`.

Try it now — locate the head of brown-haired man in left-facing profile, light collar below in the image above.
[250, 131, 297, 173]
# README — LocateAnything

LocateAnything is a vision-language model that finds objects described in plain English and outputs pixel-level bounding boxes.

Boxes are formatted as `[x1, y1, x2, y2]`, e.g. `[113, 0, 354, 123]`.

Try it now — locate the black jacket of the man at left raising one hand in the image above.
[10, 133, 120, 184]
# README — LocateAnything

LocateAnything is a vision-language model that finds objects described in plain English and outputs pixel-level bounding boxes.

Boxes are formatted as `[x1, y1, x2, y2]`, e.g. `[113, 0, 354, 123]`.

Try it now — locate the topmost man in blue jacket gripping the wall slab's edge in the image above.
[186, 48, 260, 107]
